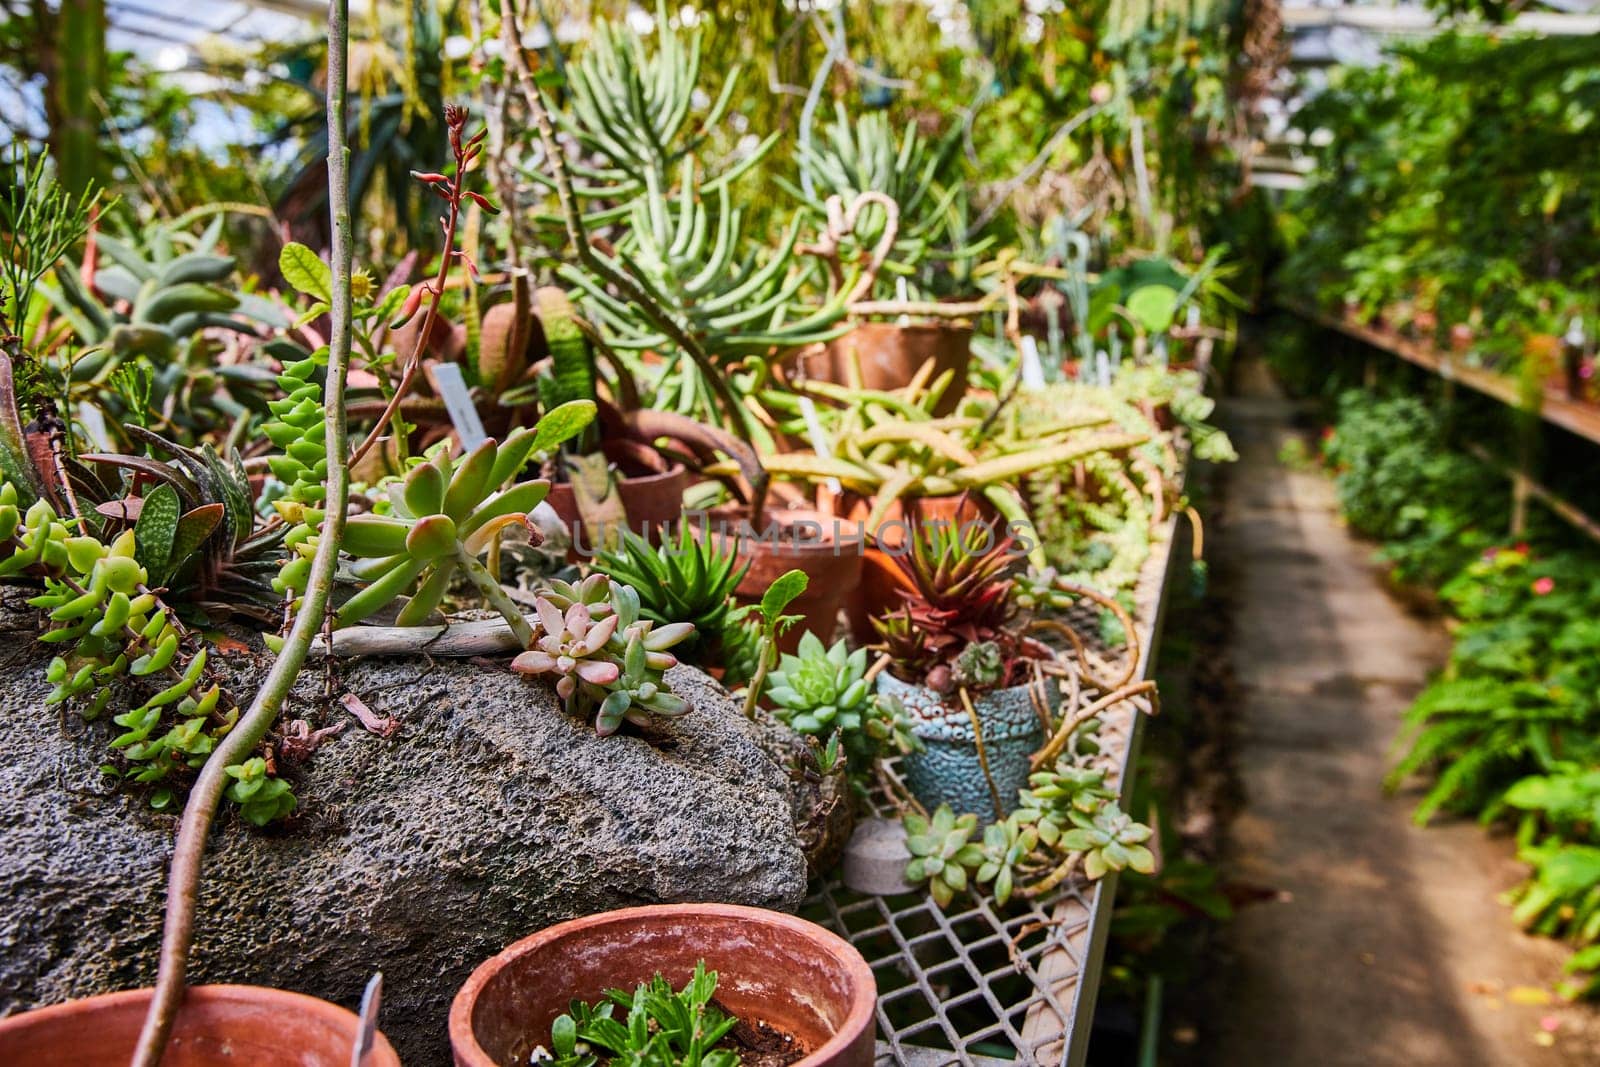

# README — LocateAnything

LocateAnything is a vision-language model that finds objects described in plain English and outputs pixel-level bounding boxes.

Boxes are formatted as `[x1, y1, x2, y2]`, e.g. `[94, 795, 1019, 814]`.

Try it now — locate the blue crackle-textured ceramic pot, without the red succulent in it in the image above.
[878, 670, 1061, 822]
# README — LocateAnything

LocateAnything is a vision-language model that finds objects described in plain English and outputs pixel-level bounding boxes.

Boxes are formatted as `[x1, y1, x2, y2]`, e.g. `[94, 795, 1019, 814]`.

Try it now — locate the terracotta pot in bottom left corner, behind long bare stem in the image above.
[0, 985, 400, 1067]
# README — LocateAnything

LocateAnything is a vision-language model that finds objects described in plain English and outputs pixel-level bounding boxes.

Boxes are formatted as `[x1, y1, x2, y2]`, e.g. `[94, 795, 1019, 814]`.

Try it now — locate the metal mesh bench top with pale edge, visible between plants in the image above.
[802, 520, 1174, 1067]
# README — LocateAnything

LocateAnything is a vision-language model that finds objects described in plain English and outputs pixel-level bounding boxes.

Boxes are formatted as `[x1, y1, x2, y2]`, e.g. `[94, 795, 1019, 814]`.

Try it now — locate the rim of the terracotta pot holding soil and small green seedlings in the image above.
[450, 904, 878, 1067]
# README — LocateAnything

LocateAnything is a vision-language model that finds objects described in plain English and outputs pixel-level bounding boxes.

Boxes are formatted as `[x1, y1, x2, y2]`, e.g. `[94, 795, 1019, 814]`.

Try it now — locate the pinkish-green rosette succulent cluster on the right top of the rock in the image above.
[512, 573, 694, 737]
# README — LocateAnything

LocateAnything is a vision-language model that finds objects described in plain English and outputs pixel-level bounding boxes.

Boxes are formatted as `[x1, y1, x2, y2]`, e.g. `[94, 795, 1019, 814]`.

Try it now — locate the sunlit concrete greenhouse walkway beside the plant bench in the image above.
[1208, 363, 1600, 1067]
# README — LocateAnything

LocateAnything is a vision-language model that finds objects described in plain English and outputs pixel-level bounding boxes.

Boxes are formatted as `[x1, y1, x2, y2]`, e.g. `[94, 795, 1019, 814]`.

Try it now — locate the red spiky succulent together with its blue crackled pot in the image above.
[874, 525, 1059, 819]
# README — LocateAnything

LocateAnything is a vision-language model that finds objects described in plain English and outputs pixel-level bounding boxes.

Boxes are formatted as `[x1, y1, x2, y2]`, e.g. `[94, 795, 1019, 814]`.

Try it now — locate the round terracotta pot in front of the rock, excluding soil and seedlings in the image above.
[450, 904, 877, 1067]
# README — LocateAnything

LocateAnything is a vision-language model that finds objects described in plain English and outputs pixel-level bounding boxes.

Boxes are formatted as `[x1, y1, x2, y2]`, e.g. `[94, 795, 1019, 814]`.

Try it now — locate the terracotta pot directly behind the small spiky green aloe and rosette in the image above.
[710, 509, 861, 653]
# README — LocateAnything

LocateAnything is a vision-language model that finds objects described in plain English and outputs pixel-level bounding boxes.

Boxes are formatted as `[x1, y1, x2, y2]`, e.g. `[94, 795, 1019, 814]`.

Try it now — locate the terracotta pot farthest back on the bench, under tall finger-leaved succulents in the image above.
[798, 322, 973, 414]
